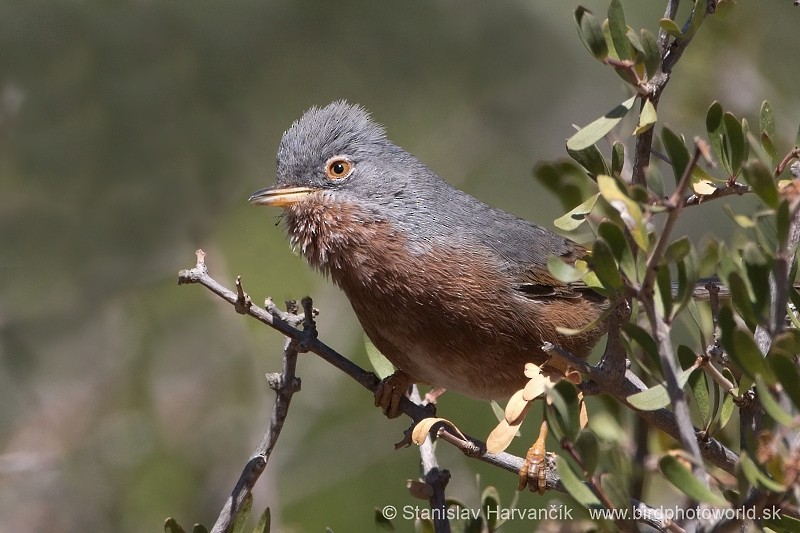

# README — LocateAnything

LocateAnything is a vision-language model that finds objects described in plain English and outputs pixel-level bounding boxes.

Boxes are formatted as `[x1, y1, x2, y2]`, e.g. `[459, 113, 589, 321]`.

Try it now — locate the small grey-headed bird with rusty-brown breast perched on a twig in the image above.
[250, 101, 608, 416]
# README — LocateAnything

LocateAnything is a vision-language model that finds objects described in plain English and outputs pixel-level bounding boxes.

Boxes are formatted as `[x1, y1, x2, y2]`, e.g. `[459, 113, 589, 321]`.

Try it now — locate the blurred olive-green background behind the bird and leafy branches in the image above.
[0, 0, 800, 532]
